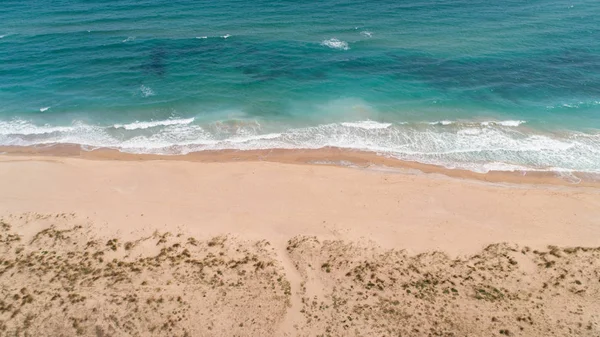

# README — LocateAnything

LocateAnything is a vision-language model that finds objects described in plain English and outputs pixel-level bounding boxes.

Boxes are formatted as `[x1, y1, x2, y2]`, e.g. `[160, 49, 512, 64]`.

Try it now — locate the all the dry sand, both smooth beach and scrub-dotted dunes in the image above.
[0, 155, 600, 336]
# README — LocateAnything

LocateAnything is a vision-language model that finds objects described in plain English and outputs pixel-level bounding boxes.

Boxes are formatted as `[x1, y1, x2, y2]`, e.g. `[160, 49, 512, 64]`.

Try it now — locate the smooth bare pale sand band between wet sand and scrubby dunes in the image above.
[0, 151, 600, 254]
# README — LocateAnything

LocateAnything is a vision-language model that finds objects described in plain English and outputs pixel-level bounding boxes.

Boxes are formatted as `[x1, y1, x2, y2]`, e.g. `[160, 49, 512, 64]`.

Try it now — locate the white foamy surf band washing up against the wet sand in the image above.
[0, 118, 600, 173]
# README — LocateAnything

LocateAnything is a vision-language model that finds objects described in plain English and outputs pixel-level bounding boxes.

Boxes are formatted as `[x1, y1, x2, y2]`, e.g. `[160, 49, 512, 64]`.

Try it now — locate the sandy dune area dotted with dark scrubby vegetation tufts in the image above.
[0, 214, 600, 336]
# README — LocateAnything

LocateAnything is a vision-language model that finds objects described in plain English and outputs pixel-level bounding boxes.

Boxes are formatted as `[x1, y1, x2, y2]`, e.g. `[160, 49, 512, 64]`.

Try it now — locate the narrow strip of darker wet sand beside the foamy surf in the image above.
[0, 144, 600, 187]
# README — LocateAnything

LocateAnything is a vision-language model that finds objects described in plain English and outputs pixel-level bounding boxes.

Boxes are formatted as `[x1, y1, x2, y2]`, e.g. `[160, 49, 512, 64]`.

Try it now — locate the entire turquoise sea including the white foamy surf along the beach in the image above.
[0, 0, 600, 172]
